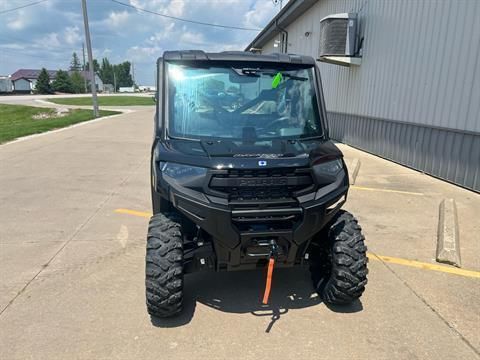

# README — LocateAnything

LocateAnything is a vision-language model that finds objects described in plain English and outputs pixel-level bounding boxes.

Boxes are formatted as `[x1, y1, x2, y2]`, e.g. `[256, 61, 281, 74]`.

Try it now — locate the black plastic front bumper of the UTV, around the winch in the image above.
[156, 171, 348, 270]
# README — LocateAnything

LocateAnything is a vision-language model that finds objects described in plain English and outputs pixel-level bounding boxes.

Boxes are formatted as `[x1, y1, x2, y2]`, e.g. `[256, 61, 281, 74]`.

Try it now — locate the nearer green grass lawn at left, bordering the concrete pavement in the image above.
[0, 104, 118, 144]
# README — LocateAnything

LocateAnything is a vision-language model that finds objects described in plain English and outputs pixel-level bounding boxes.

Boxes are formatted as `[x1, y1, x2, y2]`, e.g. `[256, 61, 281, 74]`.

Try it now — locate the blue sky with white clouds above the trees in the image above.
[0, 0, 286, 85]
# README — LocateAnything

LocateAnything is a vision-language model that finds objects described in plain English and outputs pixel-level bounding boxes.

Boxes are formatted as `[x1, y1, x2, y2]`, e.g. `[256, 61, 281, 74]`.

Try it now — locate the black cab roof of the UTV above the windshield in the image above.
[159, 50, 315, 65]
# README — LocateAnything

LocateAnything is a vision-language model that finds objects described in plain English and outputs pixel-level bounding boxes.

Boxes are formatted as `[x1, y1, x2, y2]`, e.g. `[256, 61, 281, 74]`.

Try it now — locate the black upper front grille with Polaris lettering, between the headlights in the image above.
[210, 168, 314, 201]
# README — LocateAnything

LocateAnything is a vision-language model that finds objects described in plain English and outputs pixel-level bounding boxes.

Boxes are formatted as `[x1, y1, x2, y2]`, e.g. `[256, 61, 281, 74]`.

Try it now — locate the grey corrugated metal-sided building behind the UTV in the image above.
[247, 0, 480, 191]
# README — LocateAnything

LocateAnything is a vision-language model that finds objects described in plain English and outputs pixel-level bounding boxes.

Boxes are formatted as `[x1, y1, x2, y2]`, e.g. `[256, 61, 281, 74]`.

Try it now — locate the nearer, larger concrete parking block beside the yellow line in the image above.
[436, 199, 462, 267]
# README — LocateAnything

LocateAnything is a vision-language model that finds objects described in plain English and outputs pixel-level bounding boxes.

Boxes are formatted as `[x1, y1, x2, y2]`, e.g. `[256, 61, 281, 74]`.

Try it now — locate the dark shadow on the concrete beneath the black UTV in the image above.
[152, 268, 363, 333]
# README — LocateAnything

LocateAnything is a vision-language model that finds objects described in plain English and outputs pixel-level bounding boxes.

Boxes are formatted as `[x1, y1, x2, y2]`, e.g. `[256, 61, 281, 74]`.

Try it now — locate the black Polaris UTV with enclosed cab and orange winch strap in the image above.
[145, 51, 367, 317]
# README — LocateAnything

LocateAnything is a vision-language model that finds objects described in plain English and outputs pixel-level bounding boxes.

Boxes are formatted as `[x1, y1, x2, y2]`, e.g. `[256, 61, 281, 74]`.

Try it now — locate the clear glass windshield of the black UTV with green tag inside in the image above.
[167, 63, 322, 143]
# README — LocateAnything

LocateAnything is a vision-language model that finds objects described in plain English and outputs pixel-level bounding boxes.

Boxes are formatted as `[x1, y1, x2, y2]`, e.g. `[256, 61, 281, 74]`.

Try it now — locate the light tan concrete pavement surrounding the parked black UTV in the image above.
[0, 109, 480, 360]
